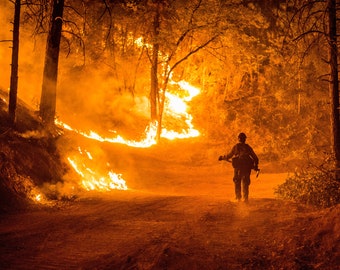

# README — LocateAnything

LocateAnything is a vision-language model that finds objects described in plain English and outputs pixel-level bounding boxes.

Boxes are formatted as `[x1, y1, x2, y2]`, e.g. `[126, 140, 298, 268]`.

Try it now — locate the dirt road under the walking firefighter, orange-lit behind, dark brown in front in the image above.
[0, 141, 340, 270]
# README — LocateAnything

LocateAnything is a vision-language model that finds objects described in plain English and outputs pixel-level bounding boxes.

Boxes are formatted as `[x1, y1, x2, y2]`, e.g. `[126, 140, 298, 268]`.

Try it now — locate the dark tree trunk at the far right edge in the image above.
[328, 0, 340, 180]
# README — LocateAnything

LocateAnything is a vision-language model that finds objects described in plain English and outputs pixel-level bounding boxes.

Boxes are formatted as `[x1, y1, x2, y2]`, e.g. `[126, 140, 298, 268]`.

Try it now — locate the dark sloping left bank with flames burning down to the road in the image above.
[0, 104, 131, 211]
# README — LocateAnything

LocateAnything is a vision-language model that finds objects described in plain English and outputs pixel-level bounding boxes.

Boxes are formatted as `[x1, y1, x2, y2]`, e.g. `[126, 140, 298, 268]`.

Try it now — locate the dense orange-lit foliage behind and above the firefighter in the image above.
[196, 0, 330, 161]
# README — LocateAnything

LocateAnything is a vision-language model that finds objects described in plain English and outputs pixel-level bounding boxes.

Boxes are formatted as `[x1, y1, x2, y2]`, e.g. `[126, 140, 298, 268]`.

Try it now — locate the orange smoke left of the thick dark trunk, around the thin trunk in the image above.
[0, 1, 46, 107]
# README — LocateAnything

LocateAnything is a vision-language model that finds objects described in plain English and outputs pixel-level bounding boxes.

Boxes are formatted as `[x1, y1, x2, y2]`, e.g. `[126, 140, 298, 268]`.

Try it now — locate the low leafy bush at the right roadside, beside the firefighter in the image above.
[275, 157, 340, 207]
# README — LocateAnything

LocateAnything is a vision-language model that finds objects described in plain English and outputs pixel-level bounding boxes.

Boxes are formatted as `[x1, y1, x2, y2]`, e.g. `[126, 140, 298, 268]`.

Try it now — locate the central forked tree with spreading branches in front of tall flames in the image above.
[122, 0, 220, 139]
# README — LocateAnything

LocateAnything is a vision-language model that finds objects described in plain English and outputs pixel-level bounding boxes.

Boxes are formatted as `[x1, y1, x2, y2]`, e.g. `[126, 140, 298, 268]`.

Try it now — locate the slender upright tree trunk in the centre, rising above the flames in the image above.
[150, 4, 160, 121]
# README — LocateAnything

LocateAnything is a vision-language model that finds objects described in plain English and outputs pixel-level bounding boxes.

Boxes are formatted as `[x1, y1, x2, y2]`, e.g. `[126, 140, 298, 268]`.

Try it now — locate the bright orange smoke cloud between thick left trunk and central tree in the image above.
[57, 64, 149, 139]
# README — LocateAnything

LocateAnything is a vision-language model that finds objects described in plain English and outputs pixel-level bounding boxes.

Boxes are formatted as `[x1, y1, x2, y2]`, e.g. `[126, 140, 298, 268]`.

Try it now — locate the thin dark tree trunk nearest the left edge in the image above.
[8, 0, 21, 126]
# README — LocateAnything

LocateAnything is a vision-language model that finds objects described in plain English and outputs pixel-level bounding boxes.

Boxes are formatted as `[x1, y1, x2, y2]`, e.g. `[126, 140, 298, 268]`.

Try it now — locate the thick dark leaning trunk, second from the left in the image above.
[40, 0, 64, 128]
